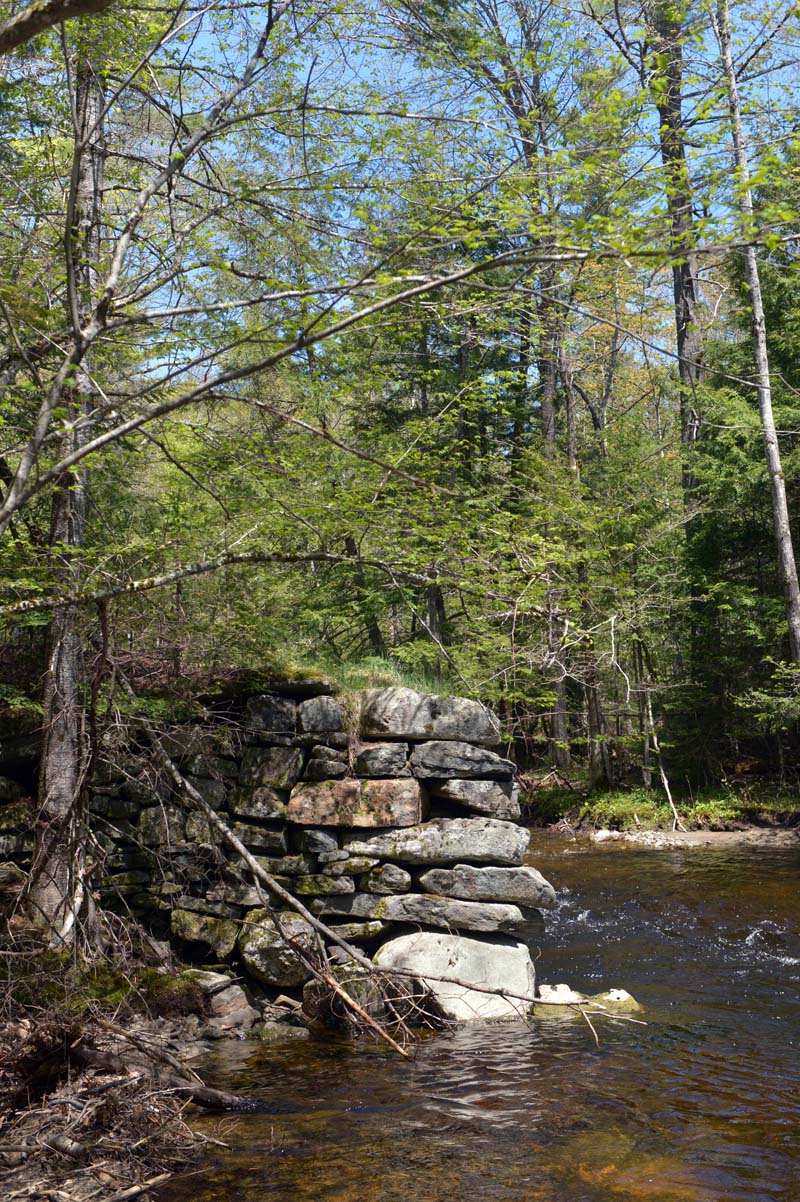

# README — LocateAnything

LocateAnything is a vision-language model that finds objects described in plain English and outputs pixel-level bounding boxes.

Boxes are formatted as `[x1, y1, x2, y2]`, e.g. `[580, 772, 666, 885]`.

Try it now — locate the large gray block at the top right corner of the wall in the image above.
[362, 688, 500, 746]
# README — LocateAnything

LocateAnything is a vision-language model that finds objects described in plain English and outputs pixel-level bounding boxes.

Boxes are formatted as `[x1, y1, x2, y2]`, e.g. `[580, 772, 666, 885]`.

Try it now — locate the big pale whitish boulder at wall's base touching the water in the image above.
[374, 932, 536, 1023]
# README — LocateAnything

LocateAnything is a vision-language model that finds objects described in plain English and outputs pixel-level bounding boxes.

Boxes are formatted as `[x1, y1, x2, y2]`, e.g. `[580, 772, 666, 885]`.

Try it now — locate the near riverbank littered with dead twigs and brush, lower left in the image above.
[0, 938, 309, 1202]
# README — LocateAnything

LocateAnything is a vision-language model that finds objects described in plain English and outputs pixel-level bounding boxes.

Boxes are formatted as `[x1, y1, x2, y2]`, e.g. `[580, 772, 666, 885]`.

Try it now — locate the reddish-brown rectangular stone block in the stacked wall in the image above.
[287, 779, 423, 827]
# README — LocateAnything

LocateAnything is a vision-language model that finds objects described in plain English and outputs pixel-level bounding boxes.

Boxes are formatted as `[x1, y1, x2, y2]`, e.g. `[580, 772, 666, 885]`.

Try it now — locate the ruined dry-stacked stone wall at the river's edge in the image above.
[0, 685, 554, 1018]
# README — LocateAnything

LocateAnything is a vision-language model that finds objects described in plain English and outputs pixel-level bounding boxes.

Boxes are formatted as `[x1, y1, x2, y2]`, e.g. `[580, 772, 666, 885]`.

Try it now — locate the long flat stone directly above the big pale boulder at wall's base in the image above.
[309, 893, 525, 933]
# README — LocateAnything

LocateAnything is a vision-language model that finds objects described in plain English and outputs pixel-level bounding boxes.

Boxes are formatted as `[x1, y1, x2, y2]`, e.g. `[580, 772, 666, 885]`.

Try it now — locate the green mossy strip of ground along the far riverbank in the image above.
[523, 785, 800, 831]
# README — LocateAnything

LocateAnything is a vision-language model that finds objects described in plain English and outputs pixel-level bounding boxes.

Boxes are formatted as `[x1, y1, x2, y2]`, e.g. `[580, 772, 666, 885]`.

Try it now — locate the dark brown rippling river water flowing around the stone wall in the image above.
[160, 832, 800, 1202]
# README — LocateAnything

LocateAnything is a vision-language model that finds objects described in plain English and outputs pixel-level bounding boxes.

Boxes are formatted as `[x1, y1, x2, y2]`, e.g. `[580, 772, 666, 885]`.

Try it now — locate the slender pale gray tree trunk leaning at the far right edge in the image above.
[715, 0, 800, 664]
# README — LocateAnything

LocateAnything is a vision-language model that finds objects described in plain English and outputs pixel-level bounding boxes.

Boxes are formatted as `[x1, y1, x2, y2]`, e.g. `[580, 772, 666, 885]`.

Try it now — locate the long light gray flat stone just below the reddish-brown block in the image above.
[346, 817, 530, 864]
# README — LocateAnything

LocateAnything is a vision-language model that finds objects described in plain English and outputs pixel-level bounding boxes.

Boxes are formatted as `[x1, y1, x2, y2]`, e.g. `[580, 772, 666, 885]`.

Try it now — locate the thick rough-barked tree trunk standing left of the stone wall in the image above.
[28, 59, 103, 947]
